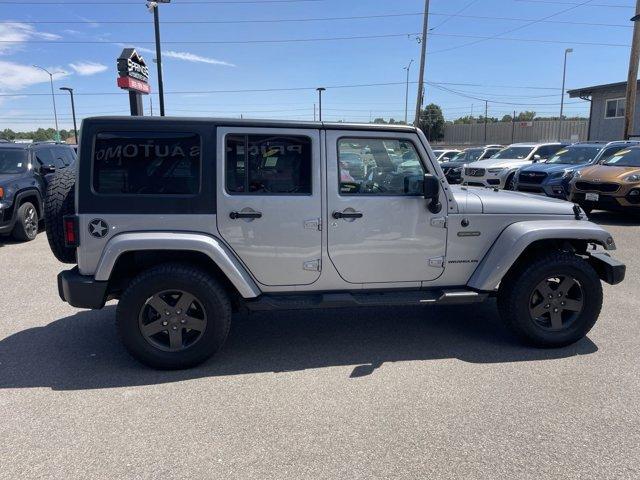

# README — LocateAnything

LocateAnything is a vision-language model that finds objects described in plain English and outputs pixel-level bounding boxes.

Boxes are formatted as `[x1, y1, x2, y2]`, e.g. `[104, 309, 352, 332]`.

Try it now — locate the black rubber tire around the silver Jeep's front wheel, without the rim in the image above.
[498, 251, 602, 348]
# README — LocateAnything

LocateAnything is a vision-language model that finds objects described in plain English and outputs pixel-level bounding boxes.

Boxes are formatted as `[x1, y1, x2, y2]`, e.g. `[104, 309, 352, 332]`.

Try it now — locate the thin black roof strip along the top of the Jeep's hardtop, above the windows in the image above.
[83, 116, 417, 133]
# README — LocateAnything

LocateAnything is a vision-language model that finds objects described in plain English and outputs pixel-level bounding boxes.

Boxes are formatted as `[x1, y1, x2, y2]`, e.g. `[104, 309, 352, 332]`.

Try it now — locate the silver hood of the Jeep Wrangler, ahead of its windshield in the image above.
[464, 187, 574, 216]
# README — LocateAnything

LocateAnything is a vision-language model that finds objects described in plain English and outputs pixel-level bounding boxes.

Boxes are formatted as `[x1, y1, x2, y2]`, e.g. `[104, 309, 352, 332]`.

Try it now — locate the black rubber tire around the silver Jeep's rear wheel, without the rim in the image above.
[116, 263, 231, 370]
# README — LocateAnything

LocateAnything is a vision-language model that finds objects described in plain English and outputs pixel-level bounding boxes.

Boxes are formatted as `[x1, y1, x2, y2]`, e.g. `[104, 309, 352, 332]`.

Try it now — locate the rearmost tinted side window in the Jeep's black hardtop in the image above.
[93, 132, 200, 195]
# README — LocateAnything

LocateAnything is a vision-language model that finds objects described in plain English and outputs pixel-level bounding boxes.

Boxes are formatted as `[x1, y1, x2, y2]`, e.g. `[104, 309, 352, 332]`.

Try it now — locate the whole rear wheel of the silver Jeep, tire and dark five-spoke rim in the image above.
[116, 264, 231, 369]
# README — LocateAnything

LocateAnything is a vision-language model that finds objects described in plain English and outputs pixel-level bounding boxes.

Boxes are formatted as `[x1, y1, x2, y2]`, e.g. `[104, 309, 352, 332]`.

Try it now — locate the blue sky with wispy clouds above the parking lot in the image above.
[0, 0, 634, 130]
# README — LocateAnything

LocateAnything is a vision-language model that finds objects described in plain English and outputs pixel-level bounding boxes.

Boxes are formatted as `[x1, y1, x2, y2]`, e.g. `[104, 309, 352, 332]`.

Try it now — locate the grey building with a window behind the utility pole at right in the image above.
[567, 82, 640, 141]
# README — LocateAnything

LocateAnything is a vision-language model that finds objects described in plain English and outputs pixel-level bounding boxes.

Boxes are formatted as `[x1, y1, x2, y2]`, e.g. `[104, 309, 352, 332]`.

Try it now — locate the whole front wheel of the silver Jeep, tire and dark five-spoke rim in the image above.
[498, 252, 602, 347]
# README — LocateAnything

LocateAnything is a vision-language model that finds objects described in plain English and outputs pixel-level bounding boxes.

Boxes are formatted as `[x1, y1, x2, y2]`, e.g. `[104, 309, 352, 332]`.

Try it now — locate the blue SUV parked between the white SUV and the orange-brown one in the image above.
[514, 141, 640, 199]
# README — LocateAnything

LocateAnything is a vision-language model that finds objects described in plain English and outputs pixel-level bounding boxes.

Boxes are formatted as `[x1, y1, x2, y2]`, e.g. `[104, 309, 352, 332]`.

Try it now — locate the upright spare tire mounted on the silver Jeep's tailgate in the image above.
[44, 168, 76, 263]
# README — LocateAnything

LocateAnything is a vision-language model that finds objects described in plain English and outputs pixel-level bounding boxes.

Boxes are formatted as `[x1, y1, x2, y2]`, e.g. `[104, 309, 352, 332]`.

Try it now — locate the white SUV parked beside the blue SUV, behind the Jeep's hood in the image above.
[462, 143, 566, 190]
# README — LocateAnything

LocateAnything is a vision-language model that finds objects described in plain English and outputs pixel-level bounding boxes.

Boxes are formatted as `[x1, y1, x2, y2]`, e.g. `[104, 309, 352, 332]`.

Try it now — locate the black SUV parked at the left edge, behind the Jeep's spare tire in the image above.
[0, 142, 76, 241]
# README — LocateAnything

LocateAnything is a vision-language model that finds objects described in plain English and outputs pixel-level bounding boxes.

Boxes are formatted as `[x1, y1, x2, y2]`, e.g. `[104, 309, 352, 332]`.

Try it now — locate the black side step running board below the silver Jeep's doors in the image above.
[242, 289, 488, 311]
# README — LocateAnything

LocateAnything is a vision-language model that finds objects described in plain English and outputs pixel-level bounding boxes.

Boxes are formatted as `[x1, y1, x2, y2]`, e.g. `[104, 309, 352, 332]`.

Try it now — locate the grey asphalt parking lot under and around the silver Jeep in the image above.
[0, 212, 640, 479]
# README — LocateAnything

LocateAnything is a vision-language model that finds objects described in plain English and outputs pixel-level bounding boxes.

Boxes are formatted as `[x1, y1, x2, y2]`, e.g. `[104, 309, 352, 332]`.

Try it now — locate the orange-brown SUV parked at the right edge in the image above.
[570, 146, 640, 212]
